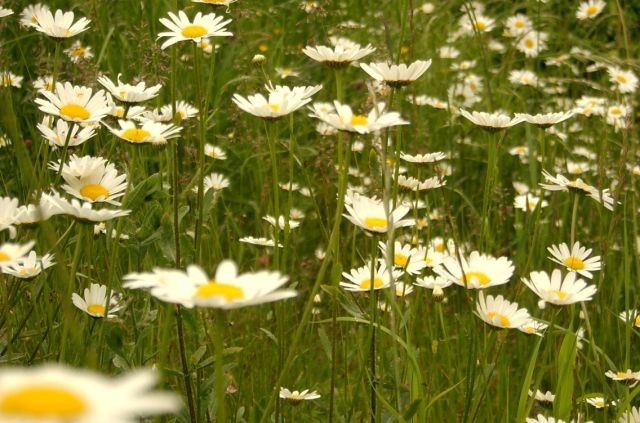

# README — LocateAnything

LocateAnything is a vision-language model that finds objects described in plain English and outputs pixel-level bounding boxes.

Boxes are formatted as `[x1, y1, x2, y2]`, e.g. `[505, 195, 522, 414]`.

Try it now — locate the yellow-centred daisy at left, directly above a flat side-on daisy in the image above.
[49, 154, 127, 206]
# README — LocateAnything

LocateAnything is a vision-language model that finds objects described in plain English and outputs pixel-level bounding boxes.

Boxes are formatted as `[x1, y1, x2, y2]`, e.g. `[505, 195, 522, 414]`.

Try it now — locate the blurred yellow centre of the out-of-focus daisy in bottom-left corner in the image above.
[0, 385, 88, 421]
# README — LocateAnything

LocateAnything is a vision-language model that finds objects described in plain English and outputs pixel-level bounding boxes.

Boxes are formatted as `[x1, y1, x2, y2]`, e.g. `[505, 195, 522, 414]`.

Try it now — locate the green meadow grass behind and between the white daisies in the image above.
[0, 0, 640, 422]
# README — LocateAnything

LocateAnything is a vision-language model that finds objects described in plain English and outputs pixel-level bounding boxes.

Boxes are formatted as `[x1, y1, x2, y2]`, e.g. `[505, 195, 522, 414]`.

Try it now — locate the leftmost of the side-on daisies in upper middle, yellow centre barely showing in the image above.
[232, 85, 322, 119]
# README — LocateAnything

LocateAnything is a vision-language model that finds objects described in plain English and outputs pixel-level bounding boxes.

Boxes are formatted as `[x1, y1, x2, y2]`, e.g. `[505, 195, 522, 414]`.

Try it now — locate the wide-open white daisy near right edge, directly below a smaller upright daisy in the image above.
[522, 269, 598, 306]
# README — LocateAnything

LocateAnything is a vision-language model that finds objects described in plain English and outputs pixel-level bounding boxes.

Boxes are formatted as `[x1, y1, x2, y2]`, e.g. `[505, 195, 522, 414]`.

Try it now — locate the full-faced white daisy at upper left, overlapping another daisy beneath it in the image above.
[35, 82, 109, 123]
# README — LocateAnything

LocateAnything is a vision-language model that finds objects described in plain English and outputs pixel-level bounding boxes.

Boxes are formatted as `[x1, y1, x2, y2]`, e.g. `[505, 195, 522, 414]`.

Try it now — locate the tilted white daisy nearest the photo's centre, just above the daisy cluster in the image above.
[343, 193, 415, 233]
